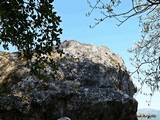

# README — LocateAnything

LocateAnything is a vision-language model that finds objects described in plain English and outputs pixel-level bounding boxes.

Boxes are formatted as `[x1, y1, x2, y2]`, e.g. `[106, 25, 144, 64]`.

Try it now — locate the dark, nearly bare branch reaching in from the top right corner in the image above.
[87, 0, 160, 28]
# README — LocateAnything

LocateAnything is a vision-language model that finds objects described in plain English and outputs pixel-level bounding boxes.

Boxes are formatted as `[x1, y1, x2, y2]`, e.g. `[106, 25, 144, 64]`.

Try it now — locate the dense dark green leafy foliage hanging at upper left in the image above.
[0, 0, 62, 77]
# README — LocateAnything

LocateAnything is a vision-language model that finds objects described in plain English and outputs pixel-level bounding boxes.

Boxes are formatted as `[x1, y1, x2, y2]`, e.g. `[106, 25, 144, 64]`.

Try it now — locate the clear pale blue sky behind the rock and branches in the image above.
[54, 0, 160, 109]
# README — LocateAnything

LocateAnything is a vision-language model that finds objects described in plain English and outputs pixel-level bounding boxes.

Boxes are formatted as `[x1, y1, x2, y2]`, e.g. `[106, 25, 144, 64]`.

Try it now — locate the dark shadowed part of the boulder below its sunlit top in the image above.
[0, 40, 138, 120]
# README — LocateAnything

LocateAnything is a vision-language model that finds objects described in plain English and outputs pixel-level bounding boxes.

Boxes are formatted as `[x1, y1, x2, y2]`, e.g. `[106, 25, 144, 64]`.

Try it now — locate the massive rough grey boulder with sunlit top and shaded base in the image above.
[0, 40, 137, 120]
